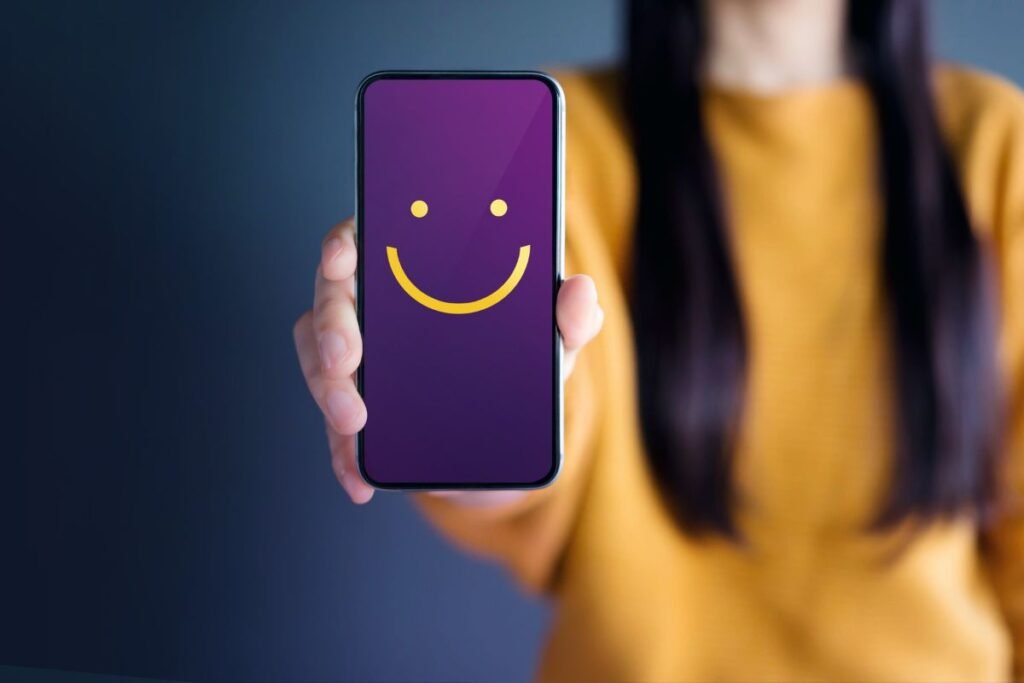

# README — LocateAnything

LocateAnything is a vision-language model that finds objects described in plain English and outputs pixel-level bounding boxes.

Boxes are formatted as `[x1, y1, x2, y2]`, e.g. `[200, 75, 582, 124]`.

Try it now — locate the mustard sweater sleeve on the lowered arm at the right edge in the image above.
[985, 78, 1024, 681]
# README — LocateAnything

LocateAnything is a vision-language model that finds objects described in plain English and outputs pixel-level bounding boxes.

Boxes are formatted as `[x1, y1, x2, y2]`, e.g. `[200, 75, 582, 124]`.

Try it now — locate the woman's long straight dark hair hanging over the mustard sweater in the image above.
[625, 0, 999, 538]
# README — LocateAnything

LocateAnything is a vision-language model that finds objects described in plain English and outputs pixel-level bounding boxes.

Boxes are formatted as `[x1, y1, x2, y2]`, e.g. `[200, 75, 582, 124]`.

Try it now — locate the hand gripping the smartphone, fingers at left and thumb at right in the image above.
[294, 218, 604, 505]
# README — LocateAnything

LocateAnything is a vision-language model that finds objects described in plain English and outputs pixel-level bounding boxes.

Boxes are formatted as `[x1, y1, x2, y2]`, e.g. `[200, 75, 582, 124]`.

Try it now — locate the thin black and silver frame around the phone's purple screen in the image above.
[355, 71, 565, 490]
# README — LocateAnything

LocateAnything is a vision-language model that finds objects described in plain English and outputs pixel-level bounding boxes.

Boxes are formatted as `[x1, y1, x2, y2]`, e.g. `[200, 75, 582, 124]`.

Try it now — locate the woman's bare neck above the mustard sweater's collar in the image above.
[703, 0, 847, 93]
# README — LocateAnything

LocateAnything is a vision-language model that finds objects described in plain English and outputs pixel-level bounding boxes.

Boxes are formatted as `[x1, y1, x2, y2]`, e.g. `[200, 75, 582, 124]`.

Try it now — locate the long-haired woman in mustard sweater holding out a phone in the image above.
[296, 0, 1024, 682]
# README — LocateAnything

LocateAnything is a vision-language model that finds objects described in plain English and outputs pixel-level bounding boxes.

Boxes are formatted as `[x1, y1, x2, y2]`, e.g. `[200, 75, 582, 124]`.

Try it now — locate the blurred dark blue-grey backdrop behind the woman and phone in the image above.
[6, 0, 1024, 681]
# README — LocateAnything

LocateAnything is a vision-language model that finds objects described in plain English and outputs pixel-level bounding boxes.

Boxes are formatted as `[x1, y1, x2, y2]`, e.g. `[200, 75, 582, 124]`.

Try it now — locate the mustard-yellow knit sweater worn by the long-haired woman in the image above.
[417, 68, 1024, 683]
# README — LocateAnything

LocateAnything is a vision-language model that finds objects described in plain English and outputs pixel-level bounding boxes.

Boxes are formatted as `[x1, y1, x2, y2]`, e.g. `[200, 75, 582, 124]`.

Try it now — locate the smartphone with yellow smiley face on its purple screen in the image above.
[355, 72, 564, 489]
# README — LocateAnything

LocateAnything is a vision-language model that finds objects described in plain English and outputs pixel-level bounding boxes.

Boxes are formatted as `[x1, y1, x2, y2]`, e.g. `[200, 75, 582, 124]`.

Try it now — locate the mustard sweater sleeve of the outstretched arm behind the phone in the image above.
[414, 69, 625, 592]
